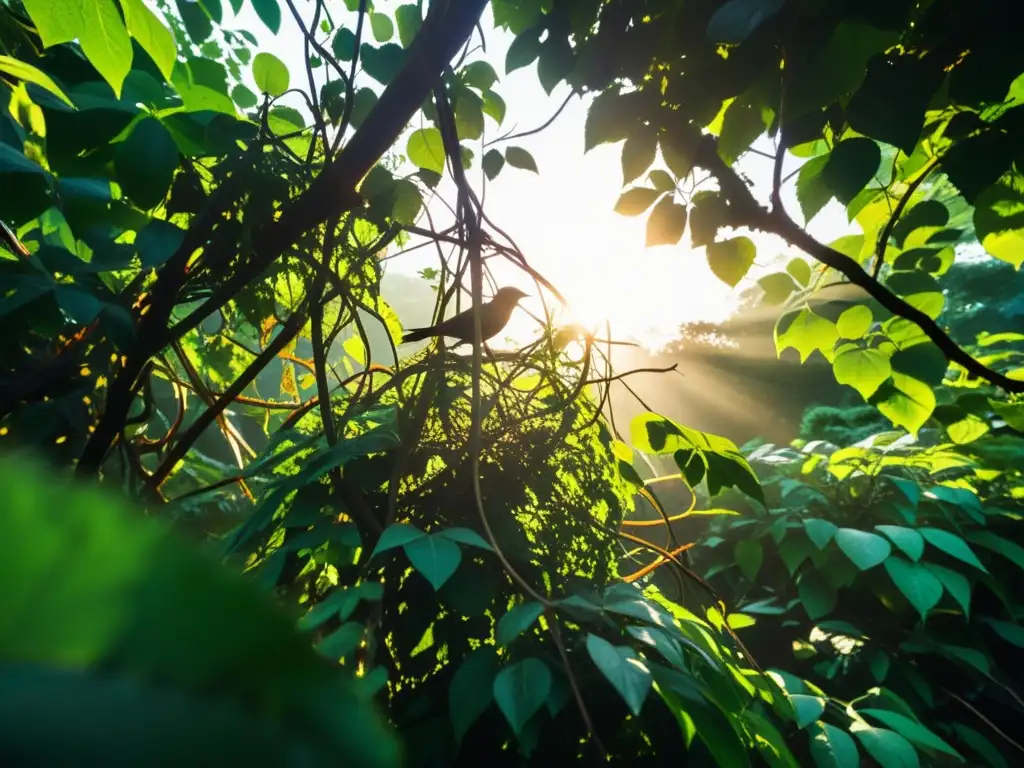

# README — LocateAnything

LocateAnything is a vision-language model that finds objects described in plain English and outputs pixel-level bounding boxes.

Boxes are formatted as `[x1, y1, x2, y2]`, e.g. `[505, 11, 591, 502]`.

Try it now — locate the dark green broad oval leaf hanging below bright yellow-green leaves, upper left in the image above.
[114, 118, 180, 209]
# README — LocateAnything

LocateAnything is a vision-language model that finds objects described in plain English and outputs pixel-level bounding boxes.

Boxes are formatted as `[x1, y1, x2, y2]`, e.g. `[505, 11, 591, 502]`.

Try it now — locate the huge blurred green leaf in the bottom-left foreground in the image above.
[0, 459, 399, 766]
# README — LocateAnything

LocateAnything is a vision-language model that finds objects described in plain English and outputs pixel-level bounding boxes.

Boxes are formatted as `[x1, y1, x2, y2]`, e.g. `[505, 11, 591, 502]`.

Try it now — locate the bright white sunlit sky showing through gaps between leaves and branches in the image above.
[225, 0, 851, 349]
